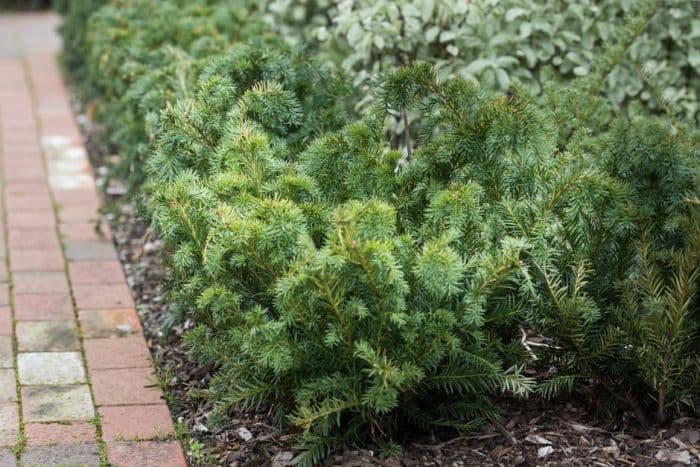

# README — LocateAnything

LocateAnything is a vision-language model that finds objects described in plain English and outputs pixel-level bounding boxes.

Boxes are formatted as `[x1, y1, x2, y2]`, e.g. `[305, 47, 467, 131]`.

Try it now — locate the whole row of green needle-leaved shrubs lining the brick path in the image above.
[57, 0, 700, 464]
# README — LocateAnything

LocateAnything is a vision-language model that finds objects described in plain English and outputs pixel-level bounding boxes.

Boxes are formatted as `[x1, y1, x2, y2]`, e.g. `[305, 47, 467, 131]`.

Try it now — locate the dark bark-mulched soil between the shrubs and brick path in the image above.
[81, 110, 700, 466]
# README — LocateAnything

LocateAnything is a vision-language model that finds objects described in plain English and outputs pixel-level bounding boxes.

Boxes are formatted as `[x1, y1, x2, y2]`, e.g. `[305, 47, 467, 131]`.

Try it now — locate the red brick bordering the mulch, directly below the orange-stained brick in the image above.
[83, 335, 151, 370]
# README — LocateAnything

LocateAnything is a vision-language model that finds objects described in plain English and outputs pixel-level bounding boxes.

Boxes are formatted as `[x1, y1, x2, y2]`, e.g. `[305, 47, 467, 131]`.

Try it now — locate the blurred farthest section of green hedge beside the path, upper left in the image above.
[85, 0, 268, 188]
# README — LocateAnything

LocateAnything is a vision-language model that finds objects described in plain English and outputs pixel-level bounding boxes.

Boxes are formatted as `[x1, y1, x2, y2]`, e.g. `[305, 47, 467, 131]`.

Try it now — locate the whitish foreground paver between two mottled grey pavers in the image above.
[17, 352, 86, 386]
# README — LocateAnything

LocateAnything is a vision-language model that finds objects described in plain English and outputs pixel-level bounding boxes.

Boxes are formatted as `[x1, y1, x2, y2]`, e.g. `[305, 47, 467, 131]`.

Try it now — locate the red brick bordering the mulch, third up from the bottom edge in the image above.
[89, 368, 163, 406]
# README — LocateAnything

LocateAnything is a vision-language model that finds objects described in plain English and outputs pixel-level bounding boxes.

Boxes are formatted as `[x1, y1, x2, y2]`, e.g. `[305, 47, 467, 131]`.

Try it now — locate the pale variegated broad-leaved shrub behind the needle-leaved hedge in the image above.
[318, 0, 700, 122]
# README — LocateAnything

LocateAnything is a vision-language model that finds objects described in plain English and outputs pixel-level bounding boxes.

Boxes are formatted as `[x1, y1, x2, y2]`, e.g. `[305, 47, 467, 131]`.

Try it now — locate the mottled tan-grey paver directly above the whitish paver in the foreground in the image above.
[16, 321, 80, 352]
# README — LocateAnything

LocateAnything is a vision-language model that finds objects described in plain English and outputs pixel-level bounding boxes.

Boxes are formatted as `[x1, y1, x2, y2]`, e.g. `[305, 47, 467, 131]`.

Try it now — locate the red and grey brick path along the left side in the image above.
[0, 13, 185, 467]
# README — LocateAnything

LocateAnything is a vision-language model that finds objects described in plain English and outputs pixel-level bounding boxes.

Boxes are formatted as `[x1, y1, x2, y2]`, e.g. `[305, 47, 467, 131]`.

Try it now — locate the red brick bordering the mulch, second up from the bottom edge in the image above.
[99, 404, 175, 441]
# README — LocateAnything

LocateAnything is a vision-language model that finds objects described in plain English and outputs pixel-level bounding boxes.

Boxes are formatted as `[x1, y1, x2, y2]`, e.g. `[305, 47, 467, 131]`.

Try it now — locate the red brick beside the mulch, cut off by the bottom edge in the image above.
[107, 441, 187, 467]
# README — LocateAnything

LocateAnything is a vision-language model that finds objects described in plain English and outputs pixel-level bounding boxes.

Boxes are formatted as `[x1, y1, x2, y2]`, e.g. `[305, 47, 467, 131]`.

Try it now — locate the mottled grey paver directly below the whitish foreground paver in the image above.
[22, 385, 95, 422]
